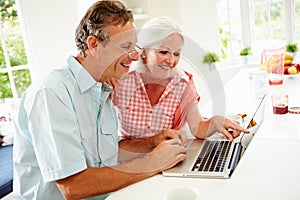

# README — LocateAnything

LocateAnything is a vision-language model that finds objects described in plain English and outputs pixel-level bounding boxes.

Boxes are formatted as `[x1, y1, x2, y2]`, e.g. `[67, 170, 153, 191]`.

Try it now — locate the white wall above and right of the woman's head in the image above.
[122, 0, 220, 52]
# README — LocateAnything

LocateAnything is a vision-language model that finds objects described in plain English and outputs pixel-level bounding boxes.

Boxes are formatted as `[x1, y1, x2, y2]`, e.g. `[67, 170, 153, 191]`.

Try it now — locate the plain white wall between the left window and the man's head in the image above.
[17, 0, 78, 81]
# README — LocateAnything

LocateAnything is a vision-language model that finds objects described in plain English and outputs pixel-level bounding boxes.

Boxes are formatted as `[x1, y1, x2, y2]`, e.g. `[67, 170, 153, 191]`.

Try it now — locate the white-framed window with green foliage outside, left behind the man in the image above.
[0, 0, 31, 101]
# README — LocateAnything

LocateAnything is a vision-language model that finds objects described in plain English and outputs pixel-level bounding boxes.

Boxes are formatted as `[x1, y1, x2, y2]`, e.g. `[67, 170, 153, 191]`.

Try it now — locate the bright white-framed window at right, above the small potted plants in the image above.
[217, 0, 300, 61]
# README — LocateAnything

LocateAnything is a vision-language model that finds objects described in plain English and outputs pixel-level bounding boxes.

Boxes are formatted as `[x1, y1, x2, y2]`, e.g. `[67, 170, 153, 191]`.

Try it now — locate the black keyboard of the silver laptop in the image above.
[192, 140, 231, 172]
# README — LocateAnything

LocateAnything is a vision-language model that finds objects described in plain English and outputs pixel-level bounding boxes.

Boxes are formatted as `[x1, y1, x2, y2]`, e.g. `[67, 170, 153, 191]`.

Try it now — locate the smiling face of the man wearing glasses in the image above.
[101, 22, 138, 81]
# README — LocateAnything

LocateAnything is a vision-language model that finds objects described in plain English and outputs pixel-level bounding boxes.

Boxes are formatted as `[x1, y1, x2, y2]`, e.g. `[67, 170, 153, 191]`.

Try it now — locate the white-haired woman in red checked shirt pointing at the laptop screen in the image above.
[113, 17, 248, 140]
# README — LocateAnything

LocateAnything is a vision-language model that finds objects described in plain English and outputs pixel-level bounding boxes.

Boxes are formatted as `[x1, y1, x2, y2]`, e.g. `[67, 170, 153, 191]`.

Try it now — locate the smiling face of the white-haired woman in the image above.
[144, 33, 183, 79]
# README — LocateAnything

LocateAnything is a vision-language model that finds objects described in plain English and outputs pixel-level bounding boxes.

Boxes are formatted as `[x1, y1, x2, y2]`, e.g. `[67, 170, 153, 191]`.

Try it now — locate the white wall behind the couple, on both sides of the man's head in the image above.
[17, 0, 219, 81]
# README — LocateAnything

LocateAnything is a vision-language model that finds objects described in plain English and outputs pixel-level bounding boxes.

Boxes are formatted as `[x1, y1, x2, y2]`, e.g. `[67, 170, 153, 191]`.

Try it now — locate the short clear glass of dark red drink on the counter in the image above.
[272, 94, 288, 115]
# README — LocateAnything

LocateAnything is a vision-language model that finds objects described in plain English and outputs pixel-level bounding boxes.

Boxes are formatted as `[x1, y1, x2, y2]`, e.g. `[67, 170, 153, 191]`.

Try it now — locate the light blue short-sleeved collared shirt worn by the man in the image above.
[14, 56, 118, 200]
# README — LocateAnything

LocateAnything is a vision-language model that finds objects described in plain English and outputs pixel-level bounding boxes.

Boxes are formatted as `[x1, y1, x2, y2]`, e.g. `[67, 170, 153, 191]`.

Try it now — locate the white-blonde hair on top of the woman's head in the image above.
[138, 16, 184, 49]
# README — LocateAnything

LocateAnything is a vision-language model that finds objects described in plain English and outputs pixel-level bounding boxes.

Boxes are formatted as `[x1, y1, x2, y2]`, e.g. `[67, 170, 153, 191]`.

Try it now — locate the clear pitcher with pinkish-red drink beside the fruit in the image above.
[261, 47, 285, 85]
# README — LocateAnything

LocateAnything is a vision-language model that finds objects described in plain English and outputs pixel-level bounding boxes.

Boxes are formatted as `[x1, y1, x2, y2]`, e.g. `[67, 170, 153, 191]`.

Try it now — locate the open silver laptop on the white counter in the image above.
[162, 95, 266, 178]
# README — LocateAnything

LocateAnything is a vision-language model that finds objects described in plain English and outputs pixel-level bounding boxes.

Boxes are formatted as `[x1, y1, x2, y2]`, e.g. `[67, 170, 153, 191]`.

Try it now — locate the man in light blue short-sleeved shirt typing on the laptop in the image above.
[14, 1, 186, 200]
